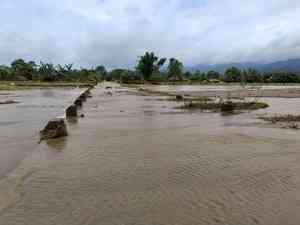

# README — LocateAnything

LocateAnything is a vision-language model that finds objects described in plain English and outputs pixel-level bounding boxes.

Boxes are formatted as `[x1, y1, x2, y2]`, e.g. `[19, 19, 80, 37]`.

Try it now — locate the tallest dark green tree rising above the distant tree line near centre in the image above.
[136, 52, 166, 80]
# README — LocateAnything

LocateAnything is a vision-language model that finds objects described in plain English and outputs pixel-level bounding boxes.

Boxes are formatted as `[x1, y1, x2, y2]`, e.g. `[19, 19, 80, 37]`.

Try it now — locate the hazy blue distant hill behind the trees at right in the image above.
[187, 59, 300, 73]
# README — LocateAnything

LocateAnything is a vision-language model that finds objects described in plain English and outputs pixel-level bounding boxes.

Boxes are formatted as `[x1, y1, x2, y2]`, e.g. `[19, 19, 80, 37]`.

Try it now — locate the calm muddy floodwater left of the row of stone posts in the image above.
[0, 88, 82, 178]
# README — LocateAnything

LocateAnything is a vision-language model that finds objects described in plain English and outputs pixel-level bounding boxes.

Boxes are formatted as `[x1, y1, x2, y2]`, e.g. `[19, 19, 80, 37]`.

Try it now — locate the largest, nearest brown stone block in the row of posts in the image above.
[40, 118, 68, 140]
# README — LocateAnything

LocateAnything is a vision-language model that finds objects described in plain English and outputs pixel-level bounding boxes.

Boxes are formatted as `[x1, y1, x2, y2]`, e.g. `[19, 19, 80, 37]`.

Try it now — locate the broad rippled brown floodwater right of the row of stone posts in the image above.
[0, 84, 300, 225]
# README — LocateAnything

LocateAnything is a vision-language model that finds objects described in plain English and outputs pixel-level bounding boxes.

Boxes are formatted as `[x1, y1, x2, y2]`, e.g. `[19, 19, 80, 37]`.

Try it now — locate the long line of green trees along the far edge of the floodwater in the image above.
[0, 52, 300, 83]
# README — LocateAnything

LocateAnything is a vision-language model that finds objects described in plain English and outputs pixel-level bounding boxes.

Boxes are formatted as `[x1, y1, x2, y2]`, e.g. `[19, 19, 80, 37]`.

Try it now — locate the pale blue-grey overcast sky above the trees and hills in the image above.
[0, 0, 300, 68]
